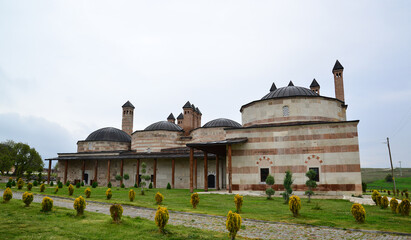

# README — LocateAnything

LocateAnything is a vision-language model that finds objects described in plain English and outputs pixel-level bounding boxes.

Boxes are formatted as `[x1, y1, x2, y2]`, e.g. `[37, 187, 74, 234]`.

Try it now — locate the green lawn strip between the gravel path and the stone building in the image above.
[0, 184, 411, 233]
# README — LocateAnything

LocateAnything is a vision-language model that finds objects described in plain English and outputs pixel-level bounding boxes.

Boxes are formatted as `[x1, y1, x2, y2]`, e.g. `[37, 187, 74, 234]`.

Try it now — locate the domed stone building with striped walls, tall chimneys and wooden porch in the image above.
[48, 60, 362, 194]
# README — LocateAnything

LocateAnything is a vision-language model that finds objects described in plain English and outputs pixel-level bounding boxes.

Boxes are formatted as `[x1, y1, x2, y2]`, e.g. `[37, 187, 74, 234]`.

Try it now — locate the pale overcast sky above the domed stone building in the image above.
[0, 0, 411, 168]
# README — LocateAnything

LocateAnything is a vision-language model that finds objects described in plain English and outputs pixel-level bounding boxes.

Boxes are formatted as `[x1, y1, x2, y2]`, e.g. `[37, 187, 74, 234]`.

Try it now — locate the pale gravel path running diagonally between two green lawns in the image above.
[0, 191, 411, 239]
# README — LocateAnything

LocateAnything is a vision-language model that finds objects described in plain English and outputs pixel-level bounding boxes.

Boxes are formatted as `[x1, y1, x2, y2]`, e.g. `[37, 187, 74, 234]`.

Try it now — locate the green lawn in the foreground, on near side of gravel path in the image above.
[0, 199, 228, 240]
